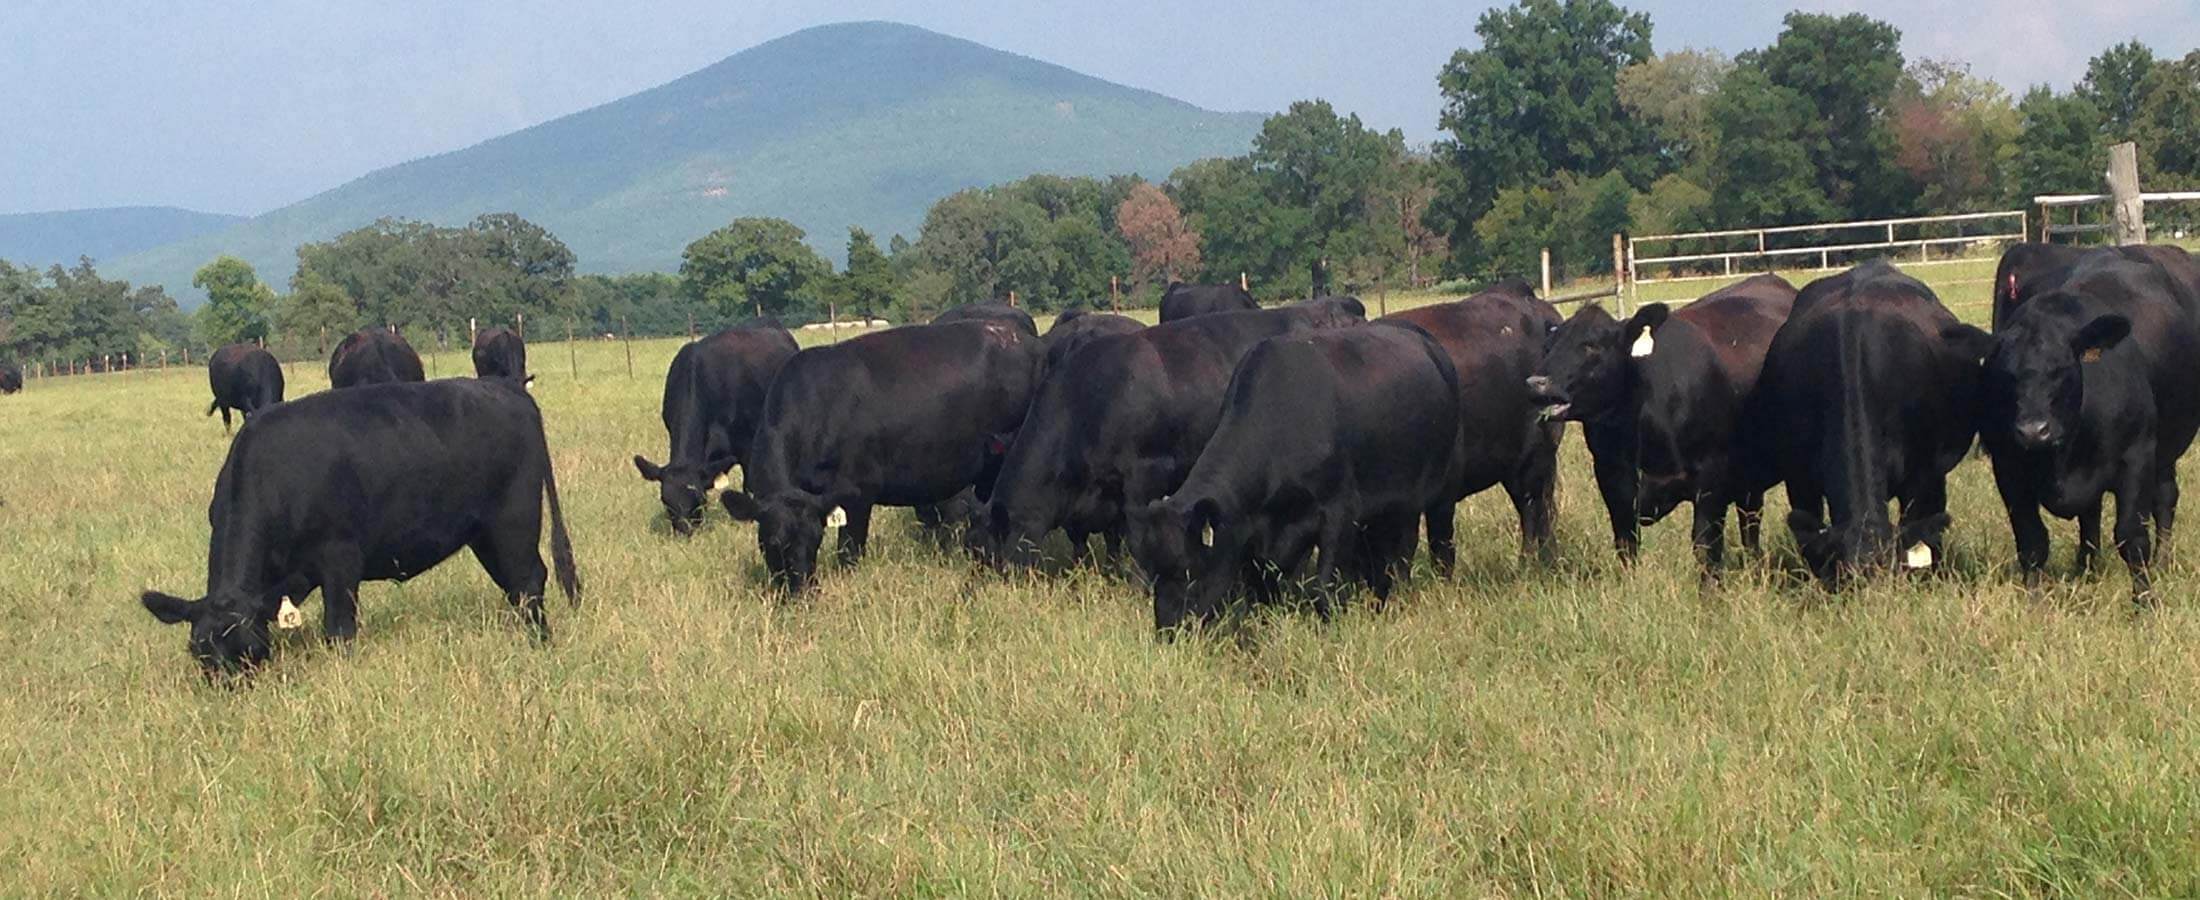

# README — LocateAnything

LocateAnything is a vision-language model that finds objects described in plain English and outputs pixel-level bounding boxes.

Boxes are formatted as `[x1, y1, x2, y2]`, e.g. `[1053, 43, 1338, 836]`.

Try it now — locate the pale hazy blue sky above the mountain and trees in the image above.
[0, 0, 2200, 213]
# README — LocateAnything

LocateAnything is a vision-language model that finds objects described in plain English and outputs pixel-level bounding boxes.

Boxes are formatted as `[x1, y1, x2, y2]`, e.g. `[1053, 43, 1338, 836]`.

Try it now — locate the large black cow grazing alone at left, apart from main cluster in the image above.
[141, 378, 581, 673]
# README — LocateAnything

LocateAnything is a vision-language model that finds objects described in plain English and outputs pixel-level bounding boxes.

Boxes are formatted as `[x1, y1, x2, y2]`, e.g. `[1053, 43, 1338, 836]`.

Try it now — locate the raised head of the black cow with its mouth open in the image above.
[1529, 304, 1668, 420]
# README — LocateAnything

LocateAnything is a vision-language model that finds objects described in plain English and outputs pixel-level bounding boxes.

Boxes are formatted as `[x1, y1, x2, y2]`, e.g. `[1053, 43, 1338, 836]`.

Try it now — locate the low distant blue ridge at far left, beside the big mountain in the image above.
[0, 207, 244, 269]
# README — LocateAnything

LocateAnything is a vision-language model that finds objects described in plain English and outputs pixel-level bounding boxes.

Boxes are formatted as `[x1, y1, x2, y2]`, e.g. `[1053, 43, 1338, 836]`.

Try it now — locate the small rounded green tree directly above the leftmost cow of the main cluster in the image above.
[680, 218, 832, 317]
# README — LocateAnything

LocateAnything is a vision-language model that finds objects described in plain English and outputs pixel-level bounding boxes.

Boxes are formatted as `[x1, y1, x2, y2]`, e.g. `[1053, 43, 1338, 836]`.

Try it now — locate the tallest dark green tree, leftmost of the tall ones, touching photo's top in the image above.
[1437, 0, 1654, 271]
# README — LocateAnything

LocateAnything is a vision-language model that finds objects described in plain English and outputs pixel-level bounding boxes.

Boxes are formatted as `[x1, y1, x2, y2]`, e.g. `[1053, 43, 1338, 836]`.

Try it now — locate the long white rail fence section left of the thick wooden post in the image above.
[1626, 209, 2031, 299]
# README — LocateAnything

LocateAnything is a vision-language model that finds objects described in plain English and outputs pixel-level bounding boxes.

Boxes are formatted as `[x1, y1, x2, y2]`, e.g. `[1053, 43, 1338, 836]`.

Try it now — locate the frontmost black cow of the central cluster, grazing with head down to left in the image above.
[1131, 321, 1461, 634]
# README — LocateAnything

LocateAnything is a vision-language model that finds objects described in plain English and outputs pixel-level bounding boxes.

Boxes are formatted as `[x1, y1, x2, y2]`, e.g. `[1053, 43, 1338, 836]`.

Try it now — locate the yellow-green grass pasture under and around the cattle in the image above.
[0, 264, 2200, 898]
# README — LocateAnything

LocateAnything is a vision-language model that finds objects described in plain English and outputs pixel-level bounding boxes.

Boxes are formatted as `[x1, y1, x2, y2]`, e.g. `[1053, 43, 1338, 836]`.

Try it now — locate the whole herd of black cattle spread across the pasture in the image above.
[111, 244, 2200, 671]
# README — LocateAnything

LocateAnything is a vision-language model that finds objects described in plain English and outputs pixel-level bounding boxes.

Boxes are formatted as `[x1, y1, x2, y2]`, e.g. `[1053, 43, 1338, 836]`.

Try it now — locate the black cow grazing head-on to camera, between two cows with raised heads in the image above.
[1745, 260, 1993, 588]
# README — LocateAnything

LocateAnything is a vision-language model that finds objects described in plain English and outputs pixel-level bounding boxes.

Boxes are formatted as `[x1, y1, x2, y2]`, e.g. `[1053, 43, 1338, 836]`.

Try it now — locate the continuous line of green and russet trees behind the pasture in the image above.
[0, 0, 2200, 361]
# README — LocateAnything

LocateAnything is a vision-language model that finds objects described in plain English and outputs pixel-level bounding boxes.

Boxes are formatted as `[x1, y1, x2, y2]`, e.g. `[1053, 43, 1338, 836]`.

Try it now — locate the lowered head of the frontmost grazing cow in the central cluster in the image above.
[1129, 500, 1236, 636]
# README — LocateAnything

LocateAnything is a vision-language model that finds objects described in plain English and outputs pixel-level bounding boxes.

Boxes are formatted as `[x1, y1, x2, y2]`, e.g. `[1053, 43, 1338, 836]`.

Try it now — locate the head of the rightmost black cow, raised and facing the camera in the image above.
[1971, 293, 2132, 449]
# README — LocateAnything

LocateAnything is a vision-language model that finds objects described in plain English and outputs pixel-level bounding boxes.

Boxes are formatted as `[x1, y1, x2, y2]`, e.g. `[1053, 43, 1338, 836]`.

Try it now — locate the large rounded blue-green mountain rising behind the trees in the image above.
[101, 22, 1263, 297]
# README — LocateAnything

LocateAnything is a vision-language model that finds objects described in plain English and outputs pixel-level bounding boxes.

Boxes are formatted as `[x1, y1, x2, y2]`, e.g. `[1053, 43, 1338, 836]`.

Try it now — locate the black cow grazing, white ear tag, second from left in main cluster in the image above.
[719, 319, 1045, 592]
